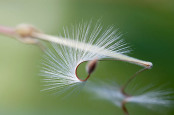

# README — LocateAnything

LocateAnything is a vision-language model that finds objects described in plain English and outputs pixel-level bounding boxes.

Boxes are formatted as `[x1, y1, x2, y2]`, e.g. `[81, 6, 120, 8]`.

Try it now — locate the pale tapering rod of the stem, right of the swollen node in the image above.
[32, 32, 152, 69]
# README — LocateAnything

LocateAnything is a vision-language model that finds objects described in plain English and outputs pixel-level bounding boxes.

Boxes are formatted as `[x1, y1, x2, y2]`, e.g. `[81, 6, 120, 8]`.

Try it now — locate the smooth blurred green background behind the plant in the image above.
[0, 0, 174, 115]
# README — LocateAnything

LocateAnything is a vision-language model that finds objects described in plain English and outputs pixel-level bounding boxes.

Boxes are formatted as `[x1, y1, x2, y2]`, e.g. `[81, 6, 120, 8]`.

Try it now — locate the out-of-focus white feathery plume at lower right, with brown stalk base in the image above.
[87, 81, 174, 115]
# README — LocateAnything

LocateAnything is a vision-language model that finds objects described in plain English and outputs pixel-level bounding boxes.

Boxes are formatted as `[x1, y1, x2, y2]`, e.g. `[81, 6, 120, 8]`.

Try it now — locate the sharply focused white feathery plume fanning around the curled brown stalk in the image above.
[41, 23, 132, 92]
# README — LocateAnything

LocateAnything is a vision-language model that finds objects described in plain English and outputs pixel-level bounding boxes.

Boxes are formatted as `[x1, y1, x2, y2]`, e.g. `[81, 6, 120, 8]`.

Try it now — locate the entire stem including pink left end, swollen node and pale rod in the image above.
[0, 25, 152, 69]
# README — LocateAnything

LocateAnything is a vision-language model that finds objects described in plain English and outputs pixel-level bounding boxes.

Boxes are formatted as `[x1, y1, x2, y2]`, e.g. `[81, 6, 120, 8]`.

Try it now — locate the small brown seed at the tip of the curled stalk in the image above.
[86, 59, 98, 74]
